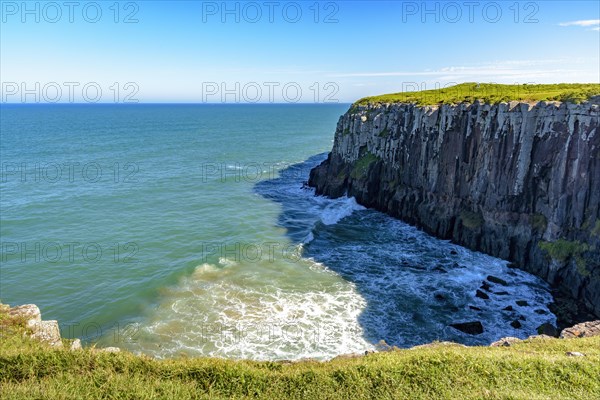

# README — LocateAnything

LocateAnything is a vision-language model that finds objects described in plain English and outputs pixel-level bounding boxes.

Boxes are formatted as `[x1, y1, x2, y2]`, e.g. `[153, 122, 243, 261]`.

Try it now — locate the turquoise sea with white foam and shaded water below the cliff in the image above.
[0, 105, 555, 359]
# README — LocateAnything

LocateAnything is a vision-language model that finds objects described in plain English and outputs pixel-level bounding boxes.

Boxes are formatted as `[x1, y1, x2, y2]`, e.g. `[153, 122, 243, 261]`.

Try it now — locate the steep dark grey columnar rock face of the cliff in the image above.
[309, 97, 600, 316]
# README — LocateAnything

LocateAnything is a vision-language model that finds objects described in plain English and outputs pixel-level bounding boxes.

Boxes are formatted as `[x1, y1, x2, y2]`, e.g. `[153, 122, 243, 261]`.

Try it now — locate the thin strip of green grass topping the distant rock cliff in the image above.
[353, 82, 600, 106]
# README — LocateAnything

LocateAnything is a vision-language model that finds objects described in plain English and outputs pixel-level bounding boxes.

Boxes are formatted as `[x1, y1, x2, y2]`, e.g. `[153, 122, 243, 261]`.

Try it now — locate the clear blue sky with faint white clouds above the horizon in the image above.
[0, 0, 600, 103]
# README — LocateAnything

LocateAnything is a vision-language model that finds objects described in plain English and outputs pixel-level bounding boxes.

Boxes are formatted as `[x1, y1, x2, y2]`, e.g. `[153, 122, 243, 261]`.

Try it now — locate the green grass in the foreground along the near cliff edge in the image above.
[0, 306, 600, 400]
